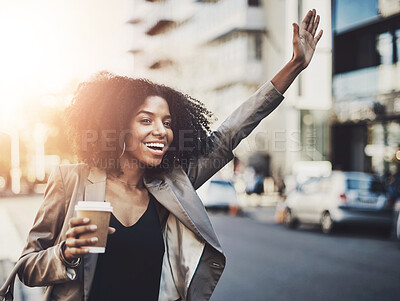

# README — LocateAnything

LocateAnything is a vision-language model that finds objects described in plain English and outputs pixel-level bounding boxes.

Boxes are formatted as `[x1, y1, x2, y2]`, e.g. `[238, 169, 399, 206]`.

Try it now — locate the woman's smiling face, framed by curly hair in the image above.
[126, 96, 174, 166]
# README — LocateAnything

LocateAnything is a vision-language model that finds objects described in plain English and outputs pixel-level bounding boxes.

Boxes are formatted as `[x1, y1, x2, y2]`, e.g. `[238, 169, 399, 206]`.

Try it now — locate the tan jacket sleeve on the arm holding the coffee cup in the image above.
[18, 167, 76, 286]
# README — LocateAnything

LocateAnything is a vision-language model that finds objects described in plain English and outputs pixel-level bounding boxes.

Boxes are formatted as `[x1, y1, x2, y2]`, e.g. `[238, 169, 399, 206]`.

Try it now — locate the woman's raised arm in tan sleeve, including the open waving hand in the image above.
[184, 9, 322, 189]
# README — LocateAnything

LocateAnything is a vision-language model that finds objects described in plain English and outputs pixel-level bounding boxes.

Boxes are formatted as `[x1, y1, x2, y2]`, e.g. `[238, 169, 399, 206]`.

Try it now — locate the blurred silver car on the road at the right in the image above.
[284, 171, 393, 233]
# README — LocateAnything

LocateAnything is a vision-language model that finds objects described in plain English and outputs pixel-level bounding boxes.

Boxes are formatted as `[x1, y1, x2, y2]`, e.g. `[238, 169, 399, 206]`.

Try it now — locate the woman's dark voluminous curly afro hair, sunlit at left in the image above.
[65, 72, 212, 174]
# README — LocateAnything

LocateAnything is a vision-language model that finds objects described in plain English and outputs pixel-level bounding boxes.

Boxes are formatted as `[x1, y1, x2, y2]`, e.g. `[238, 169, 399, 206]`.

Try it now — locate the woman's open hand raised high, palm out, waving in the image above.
[292, 9, 322, 69]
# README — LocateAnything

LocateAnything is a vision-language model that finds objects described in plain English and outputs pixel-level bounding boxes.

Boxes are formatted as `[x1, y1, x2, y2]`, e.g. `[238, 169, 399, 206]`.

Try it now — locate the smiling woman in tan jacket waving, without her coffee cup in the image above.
[19, 10, 322, 301]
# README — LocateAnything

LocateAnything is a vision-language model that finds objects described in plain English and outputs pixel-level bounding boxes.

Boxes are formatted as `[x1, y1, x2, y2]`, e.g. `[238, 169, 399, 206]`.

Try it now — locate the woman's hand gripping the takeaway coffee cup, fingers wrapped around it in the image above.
[64, 217, 115, 261]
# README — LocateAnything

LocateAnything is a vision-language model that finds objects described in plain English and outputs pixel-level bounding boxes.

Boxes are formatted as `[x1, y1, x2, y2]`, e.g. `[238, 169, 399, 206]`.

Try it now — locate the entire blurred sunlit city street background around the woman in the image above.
[0, 0, 400, 300]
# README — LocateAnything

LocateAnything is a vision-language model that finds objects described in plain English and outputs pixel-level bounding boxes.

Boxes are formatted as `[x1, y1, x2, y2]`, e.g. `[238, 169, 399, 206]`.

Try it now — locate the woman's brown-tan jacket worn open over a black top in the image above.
[19, 82, 283, 301]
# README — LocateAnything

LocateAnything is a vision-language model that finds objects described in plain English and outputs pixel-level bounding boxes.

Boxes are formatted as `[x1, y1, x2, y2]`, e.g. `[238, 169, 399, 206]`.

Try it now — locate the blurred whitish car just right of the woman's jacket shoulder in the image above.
[197, 179, 239, 215]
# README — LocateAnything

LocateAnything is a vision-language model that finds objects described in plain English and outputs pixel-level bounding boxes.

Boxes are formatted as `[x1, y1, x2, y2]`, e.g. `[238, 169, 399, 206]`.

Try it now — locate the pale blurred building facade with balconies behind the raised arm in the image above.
[130, 0, 331, 175]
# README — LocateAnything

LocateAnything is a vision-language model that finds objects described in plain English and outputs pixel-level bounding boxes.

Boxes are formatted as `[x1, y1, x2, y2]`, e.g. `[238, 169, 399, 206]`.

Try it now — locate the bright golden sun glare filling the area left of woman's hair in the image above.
[0, 0, 134, 193]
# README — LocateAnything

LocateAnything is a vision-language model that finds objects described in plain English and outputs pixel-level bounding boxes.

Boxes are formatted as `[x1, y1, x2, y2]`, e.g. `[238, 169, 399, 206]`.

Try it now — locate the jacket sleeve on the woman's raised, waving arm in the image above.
[185, 82, 284, 189]
